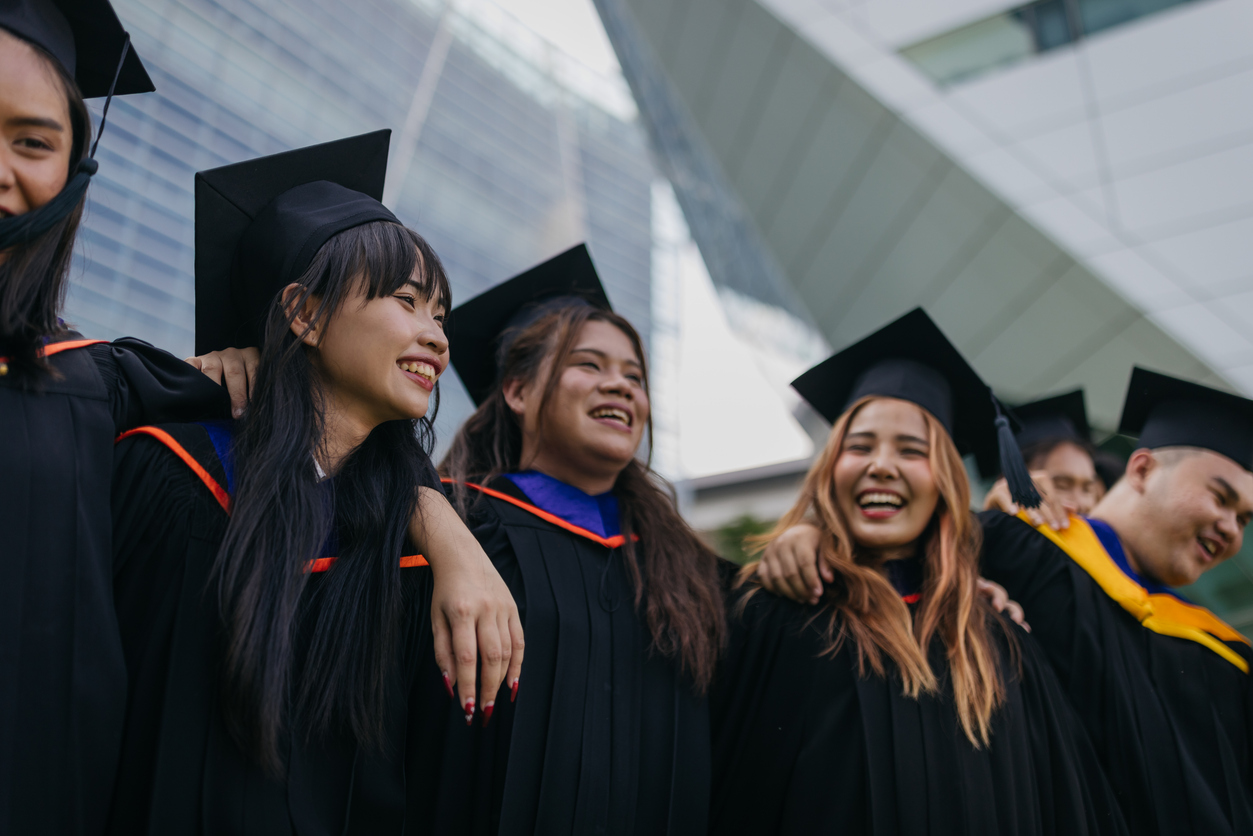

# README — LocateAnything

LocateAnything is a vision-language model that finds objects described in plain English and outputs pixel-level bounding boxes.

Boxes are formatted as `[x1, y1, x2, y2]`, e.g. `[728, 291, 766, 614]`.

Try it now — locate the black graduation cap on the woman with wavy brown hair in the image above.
[449, 244, 613, 405]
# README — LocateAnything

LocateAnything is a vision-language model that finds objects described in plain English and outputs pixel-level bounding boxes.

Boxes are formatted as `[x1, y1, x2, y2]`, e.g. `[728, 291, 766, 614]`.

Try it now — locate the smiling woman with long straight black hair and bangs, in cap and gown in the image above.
[101, 132, 521, 836]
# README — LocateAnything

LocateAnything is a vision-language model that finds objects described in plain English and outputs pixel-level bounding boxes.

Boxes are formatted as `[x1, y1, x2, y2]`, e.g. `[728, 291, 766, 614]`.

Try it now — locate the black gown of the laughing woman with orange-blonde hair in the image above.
[709, 566, 1128, 836]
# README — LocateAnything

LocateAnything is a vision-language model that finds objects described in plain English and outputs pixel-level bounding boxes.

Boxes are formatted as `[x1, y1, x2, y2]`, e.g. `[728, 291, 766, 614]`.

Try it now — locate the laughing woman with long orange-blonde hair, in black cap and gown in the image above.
[710, 311, 1126, 836]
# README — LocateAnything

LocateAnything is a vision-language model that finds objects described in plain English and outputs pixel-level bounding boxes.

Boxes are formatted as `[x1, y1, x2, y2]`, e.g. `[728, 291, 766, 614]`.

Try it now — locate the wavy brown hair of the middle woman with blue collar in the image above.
[440, 303, 727, 693]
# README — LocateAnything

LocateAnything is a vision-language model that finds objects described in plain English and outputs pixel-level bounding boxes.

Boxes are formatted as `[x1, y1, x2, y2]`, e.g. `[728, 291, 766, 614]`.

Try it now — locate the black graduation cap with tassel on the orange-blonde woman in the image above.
[792, 308, 1040, 508]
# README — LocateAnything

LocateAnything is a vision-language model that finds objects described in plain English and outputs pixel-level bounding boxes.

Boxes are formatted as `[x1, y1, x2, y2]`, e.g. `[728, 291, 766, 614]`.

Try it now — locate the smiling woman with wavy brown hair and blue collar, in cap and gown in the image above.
[420, 247, 724, 836]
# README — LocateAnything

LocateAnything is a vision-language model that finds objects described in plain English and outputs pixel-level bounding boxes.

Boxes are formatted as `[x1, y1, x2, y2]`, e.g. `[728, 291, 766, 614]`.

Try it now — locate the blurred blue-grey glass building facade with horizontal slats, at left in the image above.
[66, 0, 655, 439]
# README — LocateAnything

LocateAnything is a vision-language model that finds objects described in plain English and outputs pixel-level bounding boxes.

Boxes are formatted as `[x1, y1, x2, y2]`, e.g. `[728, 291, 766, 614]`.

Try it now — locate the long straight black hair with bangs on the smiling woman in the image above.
[214, 222, 451, 772]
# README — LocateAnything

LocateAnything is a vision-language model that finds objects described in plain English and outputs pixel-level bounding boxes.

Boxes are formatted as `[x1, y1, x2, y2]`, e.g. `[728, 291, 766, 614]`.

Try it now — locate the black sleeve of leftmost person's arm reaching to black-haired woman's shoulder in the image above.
[88, 337, 231, 432]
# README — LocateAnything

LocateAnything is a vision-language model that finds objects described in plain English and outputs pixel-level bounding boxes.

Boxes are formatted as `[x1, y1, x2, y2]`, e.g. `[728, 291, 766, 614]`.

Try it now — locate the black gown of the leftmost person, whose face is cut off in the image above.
[0, 335, 229, 833]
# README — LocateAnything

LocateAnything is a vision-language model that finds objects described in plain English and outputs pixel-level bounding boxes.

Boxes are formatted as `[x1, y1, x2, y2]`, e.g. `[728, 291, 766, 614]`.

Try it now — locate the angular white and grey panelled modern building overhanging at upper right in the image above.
[595, 0, 1253, 627]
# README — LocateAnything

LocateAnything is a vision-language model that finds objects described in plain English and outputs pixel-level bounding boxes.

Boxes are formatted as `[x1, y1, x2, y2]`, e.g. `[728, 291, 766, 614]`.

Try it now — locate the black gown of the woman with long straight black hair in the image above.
[110, 425, 450, 836]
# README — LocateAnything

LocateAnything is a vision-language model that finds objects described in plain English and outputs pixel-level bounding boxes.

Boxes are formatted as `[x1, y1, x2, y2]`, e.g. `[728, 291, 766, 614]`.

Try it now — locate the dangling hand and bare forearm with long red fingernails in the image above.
[410, 488, 525, 724]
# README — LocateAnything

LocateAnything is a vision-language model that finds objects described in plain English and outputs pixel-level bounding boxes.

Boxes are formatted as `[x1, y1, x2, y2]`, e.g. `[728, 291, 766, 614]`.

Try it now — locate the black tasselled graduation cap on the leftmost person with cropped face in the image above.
[0, 0, 157, 249]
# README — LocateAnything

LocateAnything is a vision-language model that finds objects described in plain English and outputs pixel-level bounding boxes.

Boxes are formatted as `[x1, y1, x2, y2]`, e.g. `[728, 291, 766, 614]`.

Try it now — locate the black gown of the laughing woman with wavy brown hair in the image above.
[408, 478, 710, 836]
